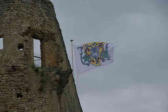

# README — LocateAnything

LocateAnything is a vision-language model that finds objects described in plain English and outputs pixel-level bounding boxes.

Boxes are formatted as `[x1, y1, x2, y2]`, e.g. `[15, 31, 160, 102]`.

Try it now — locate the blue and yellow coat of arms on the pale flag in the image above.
[78, 42, 110, 66]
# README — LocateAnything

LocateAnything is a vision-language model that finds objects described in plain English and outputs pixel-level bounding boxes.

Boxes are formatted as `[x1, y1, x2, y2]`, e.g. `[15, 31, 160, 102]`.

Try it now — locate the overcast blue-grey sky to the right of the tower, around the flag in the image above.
[50, 0, 168, 112]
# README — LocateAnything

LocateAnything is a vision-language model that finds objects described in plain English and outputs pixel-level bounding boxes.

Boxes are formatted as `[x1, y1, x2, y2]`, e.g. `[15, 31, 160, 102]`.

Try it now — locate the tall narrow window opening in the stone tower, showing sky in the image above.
[33, 39, 42, 67]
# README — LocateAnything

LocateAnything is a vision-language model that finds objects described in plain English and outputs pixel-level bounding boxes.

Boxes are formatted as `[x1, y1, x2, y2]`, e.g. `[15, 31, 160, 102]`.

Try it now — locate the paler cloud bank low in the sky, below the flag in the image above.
[80, 85, 168, 112]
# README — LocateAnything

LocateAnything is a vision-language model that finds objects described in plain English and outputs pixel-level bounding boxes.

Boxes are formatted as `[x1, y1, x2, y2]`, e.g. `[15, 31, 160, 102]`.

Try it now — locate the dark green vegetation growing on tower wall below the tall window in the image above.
[32, 65, 72, 94]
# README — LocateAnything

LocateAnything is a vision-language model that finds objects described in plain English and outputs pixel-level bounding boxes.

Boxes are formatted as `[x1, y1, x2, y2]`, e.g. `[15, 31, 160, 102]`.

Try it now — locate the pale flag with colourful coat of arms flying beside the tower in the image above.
[74, 42, 114, 73]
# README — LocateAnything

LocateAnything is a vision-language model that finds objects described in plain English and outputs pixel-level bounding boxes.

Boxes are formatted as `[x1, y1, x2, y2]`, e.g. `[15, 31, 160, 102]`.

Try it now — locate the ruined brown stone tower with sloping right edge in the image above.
[0, 0, 82, 112]
